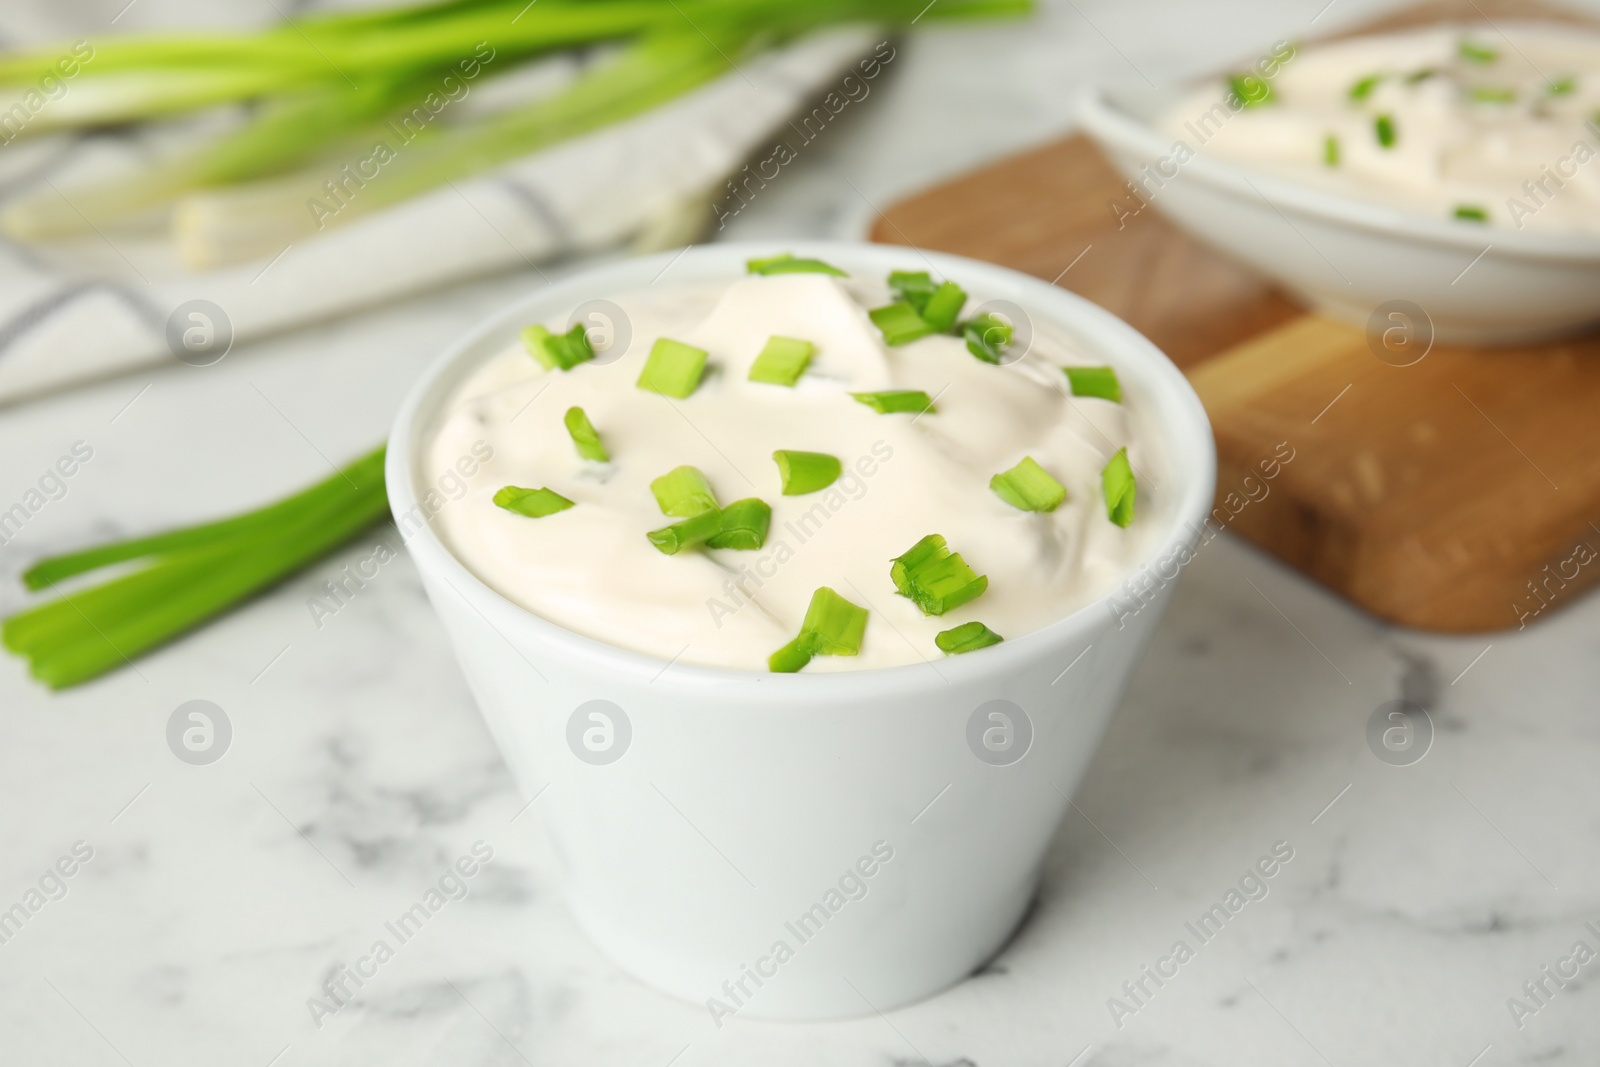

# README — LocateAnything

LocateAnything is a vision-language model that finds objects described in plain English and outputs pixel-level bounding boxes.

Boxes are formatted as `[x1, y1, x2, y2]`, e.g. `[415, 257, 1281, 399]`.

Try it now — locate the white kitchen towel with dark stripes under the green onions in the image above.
[0, 20, 893, 405]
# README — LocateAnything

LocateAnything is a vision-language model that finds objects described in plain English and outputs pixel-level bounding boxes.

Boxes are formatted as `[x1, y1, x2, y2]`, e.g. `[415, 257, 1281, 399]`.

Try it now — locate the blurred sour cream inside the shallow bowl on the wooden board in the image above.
[1162, 22, 1600, 234]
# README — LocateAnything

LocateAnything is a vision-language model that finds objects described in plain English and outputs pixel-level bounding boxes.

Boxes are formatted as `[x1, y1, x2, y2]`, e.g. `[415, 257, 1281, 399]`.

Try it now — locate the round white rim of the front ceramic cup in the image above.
[384, 240, 1216, 699]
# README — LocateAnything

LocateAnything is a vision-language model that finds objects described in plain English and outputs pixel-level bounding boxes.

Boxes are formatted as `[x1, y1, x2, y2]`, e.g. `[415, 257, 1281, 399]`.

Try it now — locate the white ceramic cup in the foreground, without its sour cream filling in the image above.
[387, 243, 1216, 1024]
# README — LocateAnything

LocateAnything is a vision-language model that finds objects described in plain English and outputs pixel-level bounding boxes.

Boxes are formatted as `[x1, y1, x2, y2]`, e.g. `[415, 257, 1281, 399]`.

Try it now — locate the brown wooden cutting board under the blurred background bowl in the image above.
[872, 134, 1600, 630]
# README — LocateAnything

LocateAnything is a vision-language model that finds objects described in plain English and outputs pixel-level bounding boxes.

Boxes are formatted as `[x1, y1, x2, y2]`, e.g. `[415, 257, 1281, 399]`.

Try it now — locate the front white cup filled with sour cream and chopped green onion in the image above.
[387, 243, 1214, 1024]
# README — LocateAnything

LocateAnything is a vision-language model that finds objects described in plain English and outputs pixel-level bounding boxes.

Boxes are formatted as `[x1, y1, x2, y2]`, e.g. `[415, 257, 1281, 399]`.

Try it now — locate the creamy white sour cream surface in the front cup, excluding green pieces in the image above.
[427, 273, 1147, 670]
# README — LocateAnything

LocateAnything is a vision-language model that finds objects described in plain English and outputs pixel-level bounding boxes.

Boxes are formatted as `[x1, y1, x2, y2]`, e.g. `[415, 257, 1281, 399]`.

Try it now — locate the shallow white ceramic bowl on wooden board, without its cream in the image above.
[1077, 86, 1600, 344]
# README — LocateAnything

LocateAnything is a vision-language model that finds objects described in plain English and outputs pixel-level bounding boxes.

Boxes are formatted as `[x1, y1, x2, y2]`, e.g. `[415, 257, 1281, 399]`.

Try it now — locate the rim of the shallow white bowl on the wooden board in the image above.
[1072, 85, 1600, 261]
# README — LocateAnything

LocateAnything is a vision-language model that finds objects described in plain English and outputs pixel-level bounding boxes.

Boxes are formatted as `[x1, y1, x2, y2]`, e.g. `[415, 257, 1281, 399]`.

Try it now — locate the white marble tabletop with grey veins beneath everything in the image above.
[0, 0, 1600, 1067]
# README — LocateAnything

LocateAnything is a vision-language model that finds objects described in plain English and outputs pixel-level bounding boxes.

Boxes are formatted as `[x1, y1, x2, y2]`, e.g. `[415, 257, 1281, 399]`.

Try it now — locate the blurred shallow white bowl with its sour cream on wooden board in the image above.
[1077, 21, 1600, 344]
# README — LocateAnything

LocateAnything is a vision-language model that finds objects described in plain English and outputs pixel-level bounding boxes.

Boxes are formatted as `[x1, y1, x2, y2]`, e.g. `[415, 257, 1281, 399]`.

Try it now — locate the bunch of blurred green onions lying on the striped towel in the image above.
[0, 0, 1030, 260]
